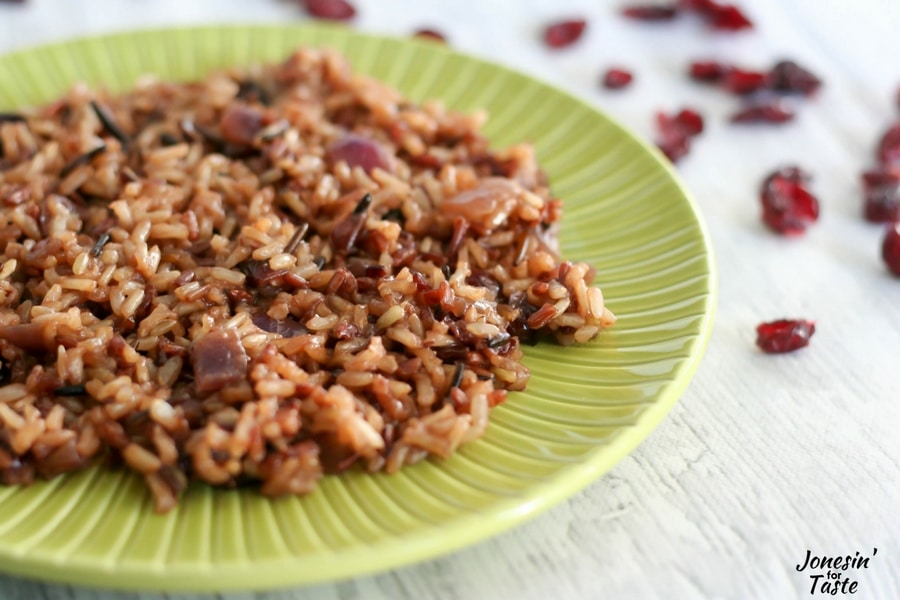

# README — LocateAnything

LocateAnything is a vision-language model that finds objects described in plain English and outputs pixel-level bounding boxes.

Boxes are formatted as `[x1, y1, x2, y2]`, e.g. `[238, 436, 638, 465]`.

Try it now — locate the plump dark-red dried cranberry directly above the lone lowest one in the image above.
[760, 167, 819, 235]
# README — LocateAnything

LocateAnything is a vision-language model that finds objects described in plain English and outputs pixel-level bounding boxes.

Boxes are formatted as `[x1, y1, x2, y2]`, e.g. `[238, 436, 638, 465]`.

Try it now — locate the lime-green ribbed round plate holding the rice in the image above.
[0, 25, 716, 591]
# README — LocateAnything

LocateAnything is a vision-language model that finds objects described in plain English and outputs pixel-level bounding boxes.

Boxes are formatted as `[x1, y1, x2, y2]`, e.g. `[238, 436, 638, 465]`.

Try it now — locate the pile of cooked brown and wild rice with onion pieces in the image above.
[0, 49, 615, 512]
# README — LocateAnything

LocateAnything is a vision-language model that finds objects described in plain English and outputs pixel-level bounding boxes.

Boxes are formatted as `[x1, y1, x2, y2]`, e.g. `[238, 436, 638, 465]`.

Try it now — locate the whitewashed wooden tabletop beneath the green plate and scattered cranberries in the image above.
[0, 0, 900, 600]
